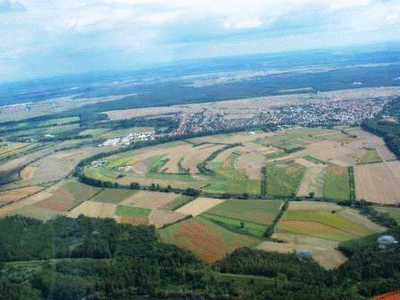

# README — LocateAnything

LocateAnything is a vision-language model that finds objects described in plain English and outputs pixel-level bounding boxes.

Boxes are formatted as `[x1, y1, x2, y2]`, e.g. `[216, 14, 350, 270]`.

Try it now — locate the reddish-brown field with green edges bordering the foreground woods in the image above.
[159, 217, 259, 263]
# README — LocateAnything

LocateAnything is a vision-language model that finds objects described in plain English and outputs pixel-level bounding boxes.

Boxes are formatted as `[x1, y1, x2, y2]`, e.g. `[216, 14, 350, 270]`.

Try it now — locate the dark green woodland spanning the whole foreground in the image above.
[0, 216, 400, 300]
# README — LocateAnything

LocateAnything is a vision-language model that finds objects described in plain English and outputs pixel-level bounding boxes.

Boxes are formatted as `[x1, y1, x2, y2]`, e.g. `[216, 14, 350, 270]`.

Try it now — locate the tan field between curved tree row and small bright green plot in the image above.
[121, 191, 179, 209]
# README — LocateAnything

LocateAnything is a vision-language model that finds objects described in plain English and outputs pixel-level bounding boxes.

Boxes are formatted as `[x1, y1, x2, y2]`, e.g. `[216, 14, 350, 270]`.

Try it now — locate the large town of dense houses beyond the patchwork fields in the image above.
[170, 98, 389, 135]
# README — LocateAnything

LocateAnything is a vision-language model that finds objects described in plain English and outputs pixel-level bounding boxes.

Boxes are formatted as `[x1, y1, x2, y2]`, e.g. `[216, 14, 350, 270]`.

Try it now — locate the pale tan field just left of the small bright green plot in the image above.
[68, 201, 117, 218]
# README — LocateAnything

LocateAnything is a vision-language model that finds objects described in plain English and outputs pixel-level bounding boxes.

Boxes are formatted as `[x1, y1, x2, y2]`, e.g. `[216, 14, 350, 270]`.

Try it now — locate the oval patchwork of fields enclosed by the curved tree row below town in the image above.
[85, 127, 400, 202]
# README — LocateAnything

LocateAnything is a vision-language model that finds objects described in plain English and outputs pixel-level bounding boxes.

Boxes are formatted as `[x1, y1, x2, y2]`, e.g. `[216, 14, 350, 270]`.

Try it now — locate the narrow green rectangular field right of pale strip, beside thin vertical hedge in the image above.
[323, 167, 350, 200]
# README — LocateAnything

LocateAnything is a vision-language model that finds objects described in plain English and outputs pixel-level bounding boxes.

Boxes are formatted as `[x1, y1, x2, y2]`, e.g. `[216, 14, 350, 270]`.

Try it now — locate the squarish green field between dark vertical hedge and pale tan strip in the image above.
[267, 161, 306, 196]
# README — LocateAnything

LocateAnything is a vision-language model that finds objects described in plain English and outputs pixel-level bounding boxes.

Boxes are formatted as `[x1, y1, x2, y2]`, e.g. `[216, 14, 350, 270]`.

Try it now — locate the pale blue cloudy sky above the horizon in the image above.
[0, 0, 400, 82]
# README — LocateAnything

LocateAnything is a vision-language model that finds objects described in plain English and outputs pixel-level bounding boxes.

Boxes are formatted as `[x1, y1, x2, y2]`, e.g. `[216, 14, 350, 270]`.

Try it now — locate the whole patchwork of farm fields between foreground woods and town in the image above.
[0, 127, 400, 269]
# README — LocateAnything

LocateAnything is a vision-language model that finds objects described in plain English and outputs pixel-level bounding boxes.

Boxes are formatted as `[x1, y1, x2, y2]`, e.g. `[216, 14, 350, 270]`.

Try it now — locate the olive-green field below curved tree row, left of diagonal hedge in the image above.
[207, 200, 283, 225]
